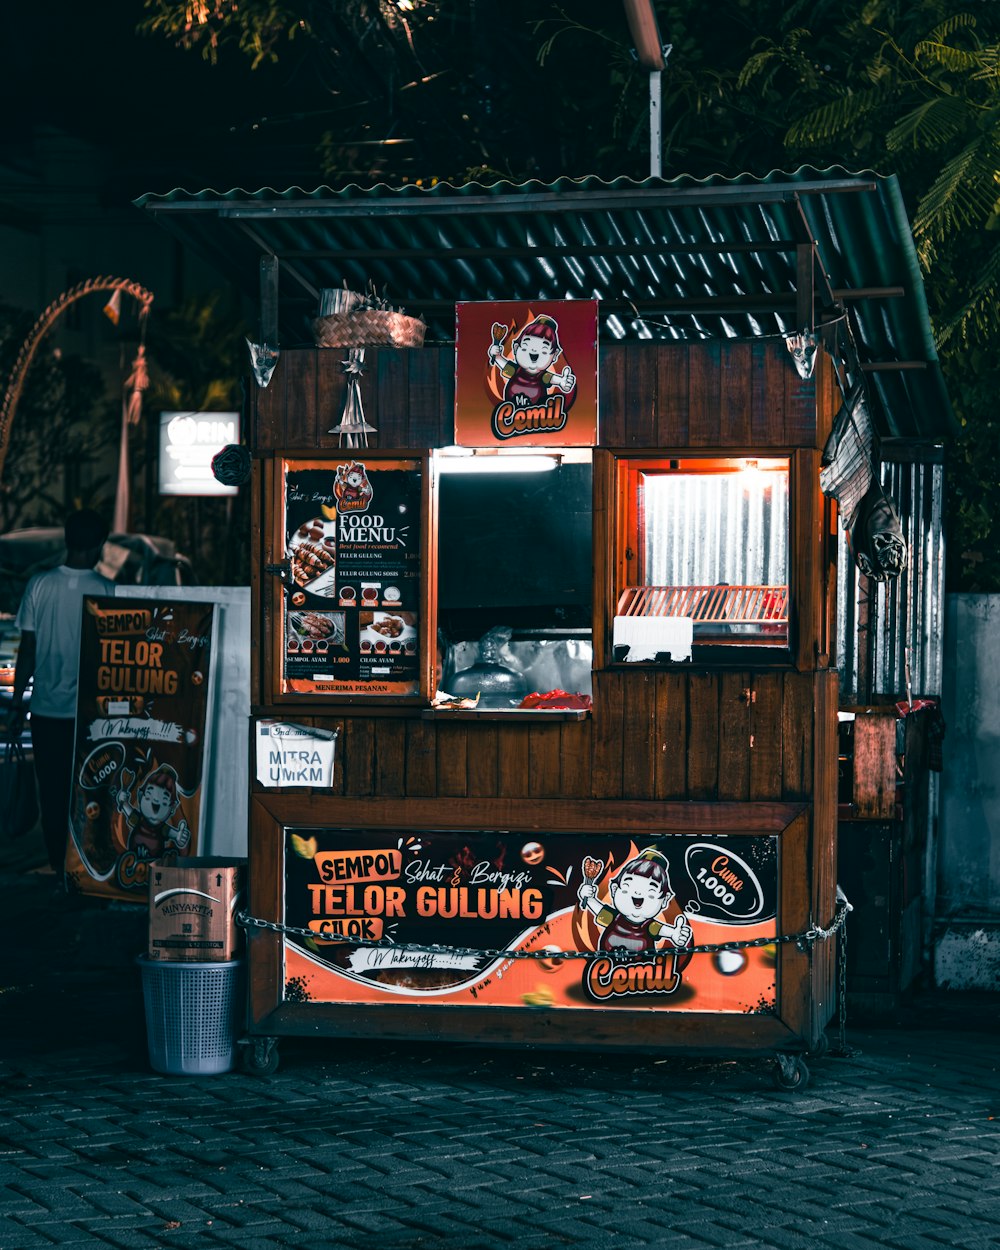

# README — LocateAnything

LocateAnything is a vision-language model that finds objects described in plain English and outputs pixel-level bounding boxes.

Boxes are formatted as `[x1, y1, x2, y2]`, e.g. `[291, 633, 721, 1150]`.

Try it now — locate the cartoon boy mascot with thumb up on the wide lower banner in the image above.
[576, 848, 693, 958]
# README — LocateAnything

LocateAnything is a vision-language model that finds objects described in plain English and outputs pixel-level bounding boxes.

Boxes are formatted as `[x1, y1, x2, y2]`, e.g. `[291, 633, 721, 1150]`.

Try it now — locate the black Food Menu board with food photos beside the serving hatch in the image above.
[283, 456, 423, 696]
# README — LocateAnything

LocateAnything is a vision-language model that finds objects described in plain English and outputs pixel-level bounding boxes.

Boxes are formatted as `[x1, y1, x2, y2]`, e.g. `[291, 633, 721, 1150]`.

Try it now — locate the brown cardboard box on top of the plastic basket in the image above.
[149, 856, 246, 963]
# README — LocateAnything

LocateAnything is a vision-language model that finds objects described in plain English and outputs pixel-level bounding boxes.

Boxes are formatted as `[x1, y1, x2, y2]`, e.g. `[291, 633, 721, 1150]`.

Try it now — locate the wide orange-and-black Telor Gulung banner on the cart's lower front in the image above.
[283, 829, 778, 1014]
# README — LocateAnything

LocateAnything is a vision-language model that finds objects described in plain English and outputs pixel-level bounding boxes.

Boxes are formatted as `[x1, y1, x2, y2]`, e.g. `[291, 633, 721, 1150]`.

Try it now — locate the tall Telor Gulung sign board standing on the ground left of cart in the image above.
[65, 596, 215, 900]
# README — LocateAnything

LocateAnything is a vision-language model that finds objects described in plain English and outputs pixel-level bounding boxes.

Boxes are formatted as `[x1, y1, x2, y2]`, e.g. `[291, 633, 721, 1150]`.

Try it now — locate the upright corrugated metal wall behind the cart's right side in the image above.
[838, 461, 945, 704]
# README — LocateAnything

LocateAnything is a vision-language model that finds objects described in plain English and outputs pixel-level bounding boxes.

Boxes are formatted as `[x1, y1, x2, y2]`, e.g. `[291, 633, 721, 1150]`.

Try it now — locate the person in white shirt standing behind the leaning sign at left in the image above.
[8, 508, 115, 875]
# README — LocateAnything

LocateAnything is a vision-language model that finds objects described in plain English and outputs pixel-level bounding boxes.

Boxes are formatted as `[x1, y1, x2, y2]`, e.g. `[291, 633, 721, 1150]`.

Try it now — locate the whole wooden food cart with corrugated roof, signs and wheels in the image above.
[143, 171, 948, 1088]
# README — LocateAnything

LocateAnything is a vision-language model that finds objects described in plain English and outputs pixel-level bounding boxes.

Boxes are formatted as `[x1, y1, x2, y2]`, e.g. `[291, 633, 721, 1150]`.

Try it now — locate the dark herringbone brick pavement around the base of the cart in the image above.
[0, 873, 1000, 1250]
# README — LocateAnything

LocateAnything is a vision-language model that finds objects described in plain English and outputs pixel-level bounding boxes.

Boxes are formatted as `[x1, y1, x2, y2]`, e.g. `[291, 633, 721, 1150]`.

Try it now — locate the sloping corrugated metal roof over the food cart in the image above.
[136, 169, 954, 441]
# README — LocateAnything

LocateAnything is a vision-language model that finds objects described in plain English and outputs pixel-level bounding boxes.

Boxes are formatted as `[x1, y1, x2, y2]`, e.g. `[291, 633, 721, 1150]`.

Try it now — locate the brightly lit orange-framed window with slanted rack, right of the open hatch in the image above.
[613, 455, 791, 663]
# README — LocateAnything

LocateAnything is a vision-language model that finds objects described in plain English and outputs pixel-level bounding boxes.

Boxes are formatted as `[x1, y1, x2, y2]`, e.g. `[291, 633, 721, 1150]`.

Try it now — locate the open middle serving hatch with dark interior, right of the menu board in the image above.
[435, 449, 594, 715]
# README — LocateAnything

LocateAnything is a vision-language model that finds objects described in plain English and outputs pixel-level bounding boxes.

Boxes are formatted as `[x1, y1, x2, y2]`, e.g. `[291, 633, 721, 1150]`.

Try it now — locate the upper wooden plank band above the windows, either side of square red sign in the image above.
[249, 340, 810, 453]
